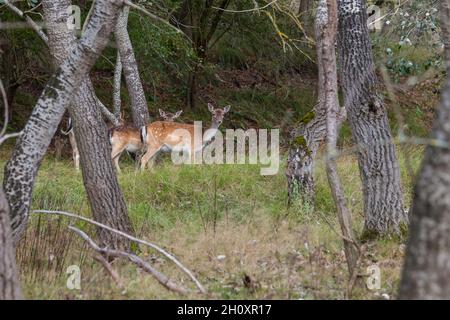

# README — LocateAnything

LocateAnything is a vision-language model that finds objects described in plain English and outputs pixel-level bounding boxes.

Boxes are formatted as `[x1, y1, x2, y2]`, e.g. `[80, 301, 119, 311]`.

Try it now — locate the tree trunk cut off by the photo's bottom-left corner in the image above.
[0, 187, 22, 300]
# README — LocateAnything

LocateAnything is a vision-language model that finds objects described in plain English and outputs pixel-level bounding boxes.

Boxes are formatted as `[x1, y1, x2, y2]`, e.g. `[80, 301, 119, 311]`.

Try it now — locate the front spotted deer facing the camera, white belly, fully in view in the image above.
[141, 103, 231, 171]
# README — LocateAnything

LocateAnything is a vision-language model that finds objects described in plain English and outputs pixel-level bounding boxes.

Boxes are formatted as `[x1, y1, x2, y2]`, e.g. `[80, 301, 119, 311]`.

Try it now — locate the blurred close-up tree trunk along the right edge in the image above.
[399, 0, 450, 299]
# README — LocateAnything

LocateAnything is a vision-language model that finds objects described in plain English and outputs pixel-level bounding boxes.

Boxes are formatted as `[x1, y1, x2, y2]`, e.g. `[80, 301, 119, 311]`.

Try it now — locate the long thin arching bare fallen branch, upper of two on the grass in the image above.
[33, 210, 206, 294]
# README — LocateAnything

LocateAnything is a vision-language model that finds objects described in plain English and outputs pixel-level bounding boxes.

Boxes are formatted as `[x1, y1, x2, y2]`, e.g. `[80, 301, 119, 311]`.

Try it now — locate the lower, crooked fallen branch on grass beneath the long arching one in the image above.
[69, 226, 188, 295]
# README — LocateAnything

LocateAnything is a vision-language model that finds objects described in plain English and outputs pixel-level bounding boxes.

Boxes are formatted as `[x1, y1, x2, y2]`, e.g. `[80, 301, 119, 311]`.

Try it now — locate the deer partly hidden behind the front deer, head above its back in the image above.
[108, 109, 183, 173]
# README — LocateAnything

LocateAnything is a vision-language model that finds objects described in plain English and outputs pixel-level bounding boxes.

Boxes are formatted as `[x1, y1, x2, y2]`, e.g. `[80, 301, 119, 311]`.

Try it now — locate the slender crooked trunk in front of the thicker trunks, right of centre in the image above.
[315, 0, 358, 277]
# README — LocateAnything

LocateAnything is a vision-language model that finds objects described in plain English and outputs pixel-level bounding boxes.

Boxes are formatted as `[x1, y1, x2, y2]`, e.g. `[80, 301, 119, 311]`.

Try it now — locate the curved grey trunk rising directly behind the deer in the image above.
[115, 6, 150, 128]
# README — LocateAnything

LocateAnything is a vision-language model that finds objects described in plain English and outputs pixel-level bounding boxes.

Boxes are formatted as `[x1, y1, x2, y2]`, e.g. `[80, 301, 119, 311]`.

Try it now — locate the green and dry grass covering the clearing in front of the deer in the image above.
[0, 142, 421, 299]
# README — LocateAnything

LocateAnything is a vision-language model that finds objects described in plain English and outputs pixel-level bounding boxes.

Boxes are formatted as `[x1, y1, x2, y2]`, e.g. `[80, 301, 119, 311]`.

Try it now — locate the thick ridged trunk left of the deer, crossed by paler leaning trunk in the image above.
[42, 0, 133, 248]
